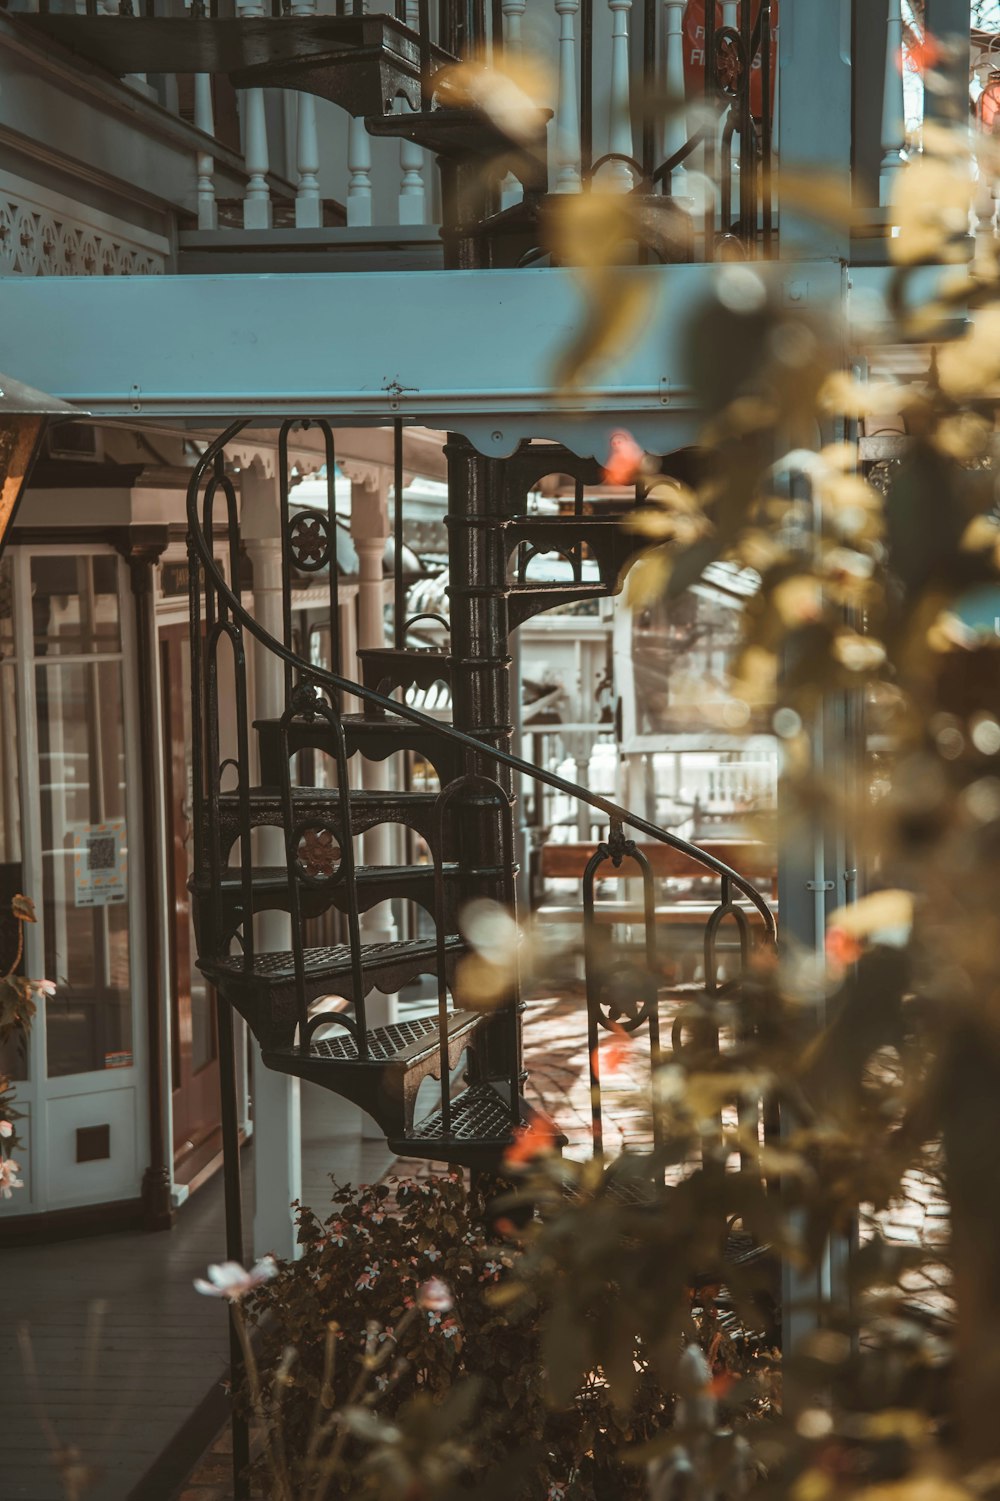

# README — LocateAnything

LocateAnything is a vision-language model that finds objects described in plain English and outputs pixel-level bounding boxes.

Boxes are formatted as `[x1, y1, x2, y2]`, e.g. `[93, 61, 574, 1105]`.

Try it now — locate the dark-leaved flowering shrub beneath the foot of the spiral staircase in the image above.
[242, 1175, 671, 1501]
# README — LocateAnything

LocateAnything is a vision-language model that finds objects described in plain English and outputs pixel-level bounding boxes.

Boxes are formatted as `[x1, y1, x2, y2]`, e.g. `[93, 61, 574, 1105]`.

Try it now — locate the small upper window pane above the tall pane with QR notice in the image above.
[32, 555, 122, 656]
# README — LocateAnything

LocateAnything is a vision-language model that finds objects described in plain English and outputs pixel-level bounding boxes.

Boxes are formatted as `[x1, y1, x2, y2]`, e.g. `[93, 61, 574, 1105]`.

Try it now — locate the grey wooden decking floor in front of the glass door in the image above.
[0, 1084, 392, 1501]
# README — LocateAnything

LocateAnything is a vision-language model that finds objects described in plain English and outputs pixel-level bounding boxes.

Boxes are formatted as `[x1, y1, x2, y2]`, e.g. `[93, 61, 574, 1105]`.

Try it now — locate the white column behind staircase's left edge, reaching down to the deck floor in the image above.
[240, 459, 302, 1258]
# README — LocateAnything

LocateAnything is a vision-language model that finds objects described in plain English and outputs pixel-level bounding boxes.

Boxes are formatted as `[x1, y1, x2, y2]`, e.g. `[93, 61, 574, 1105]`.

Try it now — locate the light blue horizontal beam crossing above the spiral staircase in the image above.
[2, 263, 844, 456]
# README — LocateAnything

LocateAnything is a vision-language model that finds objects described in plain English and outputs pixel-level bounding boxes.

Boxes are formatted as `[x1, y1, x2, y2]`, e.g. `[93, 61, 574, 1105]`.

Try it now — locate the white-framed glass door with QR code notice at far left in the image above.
[0, 545, 147, 1213]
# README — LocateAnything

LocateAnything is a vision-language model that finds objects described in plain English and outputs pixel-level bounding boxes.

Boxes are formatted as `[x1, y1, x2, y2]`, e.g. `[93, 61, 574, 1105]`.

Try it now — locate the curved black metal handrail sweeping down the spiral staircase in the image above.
[188, 420, 778, 943]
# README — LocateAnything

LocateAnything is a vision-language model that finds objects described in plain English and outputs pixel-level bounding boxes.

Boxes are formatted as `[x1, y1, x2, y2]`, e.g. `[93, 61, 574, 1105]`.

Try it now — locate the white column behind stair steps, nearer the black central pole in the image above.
[351, 482, 398, 1141]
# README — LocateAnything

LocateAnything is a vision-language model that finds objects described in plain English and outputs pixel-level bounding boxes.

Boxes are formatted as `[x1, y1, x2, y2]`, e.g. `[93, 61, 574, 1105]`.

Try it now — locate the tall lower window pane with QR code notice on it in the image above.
[36, 662, 132, 1075]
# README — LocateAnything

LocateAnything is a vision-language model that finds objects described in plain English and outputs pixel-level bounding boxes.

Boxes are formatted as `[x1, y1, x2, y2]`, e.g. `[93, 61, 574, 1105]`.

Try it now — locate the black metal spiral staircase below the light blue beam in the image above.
[188, 423, 775, 1169]
